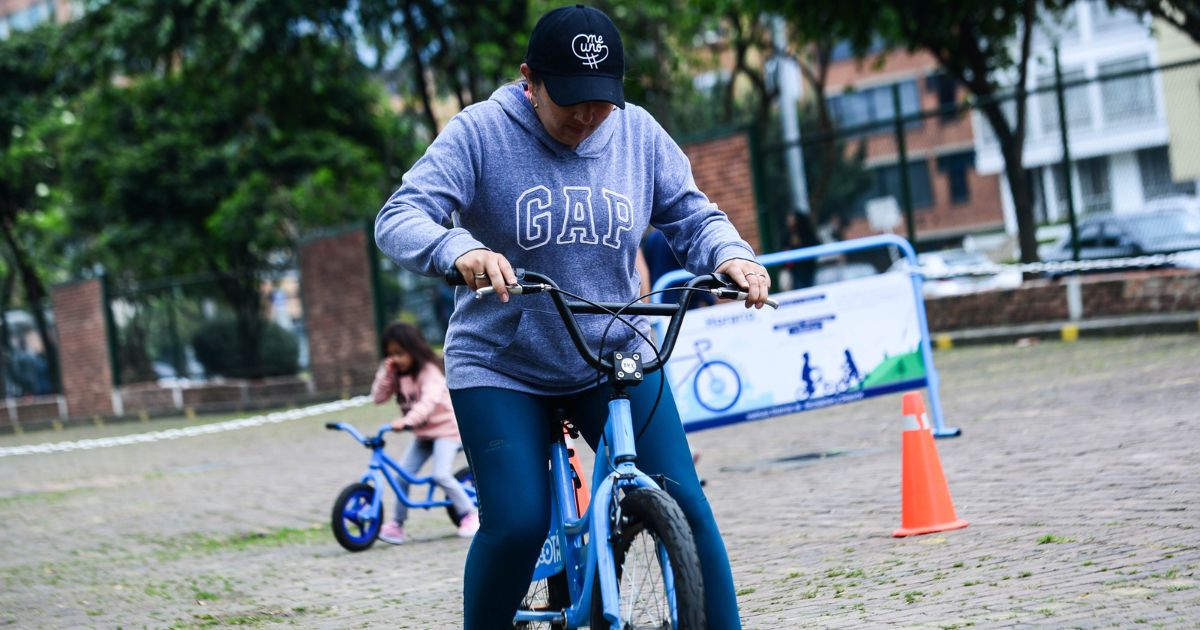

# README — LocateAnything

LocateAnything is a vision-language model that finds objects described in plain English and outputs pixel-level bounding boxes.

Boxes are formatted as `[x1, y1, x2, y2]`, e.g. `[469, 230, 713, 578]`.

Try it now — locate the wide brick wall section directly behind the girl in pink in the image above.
[299, 229, 379, 395]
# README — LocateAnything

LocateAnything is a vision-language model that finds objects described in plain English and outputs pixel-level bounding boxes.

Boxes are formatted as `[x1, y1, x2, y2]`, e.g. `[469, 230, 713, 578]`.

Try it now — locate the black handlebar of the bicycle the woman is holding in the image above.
[445, 269, 779, 374]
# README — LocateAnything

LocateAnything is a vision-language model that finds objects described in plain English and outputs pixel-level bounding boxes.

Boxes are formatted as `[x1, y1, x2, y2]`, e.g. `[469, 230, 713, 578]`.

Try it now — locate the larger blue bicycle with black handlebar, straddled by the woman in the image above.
[458, 270, 778, 630]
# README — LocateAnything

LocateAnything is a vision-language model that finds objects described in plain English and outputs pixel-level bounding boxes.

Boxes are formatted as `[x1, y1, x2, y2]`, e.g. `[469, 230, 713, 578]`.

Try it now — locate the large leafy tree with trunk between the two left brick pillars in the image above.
[64, 0, 414, 374]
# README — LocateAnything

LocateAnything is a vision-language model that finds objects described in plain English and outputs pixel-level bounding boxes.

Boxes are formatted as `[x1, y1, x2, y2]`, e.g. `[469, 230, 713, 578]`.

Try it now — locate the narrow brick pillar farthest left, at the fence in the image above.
[53, 280, 114, 418]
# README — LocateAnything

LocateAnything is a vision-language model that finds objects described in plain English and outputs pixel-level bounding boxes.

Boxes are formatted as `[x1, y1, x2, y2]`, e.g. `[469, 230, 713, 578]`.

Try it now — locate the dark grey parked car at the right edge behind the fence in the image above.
[1045, 209, 1200, 268]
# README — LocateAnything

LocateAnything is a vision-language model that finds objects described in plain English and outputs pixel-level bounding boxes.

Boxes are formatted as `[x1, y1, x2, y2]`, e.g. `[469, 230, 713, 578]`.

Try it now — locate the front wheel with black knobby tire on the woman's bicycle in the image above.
[592, 488, 708, 630]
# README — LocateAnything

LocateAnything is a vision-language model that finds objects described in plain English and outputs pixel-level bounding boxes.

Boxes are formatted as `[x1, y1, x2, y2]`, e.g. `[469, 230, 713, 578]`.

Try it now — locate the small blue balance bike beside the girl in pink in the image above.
[325, 422, 476, 551]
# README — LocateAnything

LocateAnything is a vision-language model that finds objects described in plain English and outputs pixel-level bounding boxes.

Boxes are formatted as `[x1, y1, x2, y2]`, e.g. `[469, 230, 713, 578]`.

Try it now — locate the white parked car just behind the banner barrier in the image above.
[892, 250, 1021, 298]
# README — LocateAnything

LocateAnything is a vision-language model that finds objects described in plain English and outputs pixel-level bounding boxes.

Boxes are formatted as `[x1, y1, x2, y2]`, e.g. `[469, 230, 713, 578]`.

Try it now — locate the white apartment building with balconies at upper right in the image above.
[972, 0, 1200, 233]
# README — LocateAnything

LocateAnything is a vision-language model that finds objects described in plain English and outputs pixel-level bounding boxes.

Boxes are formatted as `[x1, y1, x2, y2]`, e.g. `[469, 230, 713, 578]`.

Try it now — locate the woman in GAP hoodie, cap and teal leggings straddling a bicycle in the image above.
[376, 5, 770, 630]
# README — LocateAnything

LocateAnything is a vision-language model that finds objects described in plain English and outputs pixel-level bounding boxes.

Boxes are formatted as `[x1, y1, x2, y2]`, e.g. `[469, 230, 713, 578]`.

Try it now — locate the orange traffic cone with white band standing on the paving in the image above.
[892, 391, 967, 536]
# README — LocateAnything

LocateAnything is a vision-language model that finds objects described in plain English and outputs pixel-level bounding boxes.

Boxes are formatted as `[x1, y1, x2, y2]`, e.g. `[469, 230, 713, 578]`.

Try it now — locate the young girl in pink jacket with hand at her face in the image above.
[371, 323, 479, 545]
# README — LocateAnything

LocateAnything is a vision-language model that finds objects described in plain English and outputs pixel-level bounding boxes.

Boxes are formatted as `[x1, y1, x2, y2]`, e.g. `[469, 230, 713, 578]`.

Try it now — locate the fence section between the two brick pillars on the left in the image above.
[107, 271, 308, 385]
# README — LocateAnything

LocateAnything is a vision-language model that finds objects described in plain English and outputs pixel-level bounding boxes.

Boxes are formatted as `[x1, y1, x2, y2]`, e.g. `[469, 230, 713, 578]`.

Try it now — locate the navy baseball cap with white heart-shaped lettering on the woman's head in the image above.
[526, 5, 625, 109]
